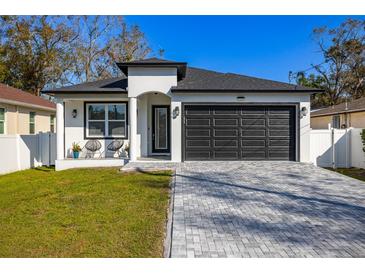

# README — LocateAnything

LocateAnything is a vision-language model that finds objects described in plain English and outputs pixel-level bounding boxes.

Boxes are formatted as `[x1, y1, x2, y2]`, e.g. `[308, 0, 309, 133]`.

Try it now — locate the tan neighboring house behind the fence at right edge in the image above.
[311, 97, 365, 129]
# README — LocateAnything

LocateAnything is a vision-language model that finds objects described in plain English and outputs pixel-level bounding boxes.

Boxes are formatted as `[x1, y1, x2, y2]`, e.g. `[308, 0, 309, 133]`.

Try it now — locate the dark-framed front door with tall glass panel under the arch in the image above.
[152, 106, 170, 153]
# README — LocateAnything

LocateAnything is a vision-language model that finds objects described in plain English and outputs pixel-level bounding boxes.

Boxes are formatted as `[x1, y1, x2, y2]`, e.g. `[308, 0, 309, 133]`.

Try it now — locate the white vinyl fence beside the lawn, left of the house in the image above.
[0, 133, 56, 174]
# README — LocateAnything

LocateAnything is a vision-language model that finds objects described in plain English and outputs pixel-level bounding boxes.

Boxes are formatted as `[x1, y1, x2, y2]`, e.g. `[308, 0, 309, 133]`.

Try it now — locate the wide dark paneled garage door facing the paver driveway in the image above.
[183, 105, 296, 161]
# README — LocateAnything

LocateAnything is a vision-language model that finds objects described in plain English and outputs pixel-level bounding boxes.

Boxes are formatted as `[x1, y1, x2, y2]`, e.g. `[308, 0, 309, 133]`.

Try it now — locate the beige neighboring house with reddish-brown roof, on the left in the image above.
[0, 84, 56, 135]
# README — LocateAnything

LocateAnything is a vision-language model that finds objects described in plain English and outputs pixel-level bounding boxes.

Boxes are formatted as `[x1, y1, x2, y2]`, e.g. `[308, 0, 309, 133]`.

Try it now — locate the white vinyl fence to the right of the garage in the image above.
[310, 128, 365, 168]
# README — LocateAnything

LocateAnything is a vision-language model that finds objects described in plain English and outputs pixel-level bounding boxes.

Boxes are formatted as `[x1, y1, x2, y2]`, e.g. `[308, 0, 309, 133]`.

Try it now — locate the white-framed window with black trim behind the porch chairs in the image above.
[85, 103, 127, 138]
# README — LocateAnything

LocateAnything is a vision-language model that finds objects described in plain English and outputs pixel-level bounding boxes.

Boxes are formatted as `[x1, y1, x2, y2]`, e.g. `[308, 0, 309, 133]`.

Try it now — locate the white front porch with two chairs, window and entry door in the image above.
[55, 92, 180, 170]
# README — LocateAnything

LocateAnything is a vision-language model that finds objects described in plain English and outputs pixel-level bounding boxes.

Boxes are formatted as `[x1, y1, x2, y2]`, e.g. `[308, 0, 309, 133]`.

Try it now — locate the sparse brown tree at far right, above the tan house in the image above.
[294, 19, 365, 106]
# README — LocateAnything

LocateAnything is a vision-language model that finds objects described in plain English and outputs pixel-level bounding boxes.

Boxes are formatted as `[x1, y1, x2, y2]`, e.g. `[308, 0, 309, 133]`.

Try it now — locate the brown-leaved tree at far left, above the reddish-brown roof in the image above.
[0, 16, 77, 95]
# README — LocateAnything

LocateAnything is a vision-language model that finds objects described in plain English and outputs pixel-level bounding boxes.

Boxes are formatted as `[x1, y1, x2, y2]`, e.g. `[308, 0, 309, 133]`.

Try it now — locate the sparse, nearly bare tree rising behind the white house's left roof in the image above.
[70, 16, 151, 82]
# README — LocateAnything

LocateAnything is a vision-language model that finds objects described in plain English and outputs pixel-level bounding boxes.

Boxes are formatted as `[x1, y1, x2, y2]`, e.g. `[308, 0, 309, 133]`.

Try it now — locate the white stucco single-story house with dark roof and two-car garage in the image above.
[44, 58, 318, 169]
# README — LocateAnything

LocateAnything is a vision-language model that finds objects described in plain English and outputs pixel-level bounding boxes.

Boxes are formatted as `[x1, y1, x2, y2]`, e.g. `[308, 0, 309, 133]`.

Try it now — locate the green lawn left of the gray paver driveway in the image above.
[0, 168, 171, 257]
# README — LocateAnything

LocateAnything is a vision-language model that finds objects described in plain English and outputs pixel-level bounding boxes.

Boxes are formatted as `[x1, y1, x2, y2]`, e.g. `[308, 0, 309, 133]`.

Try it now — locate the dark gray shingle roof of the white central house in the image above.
[44, 58, 320, 94]
